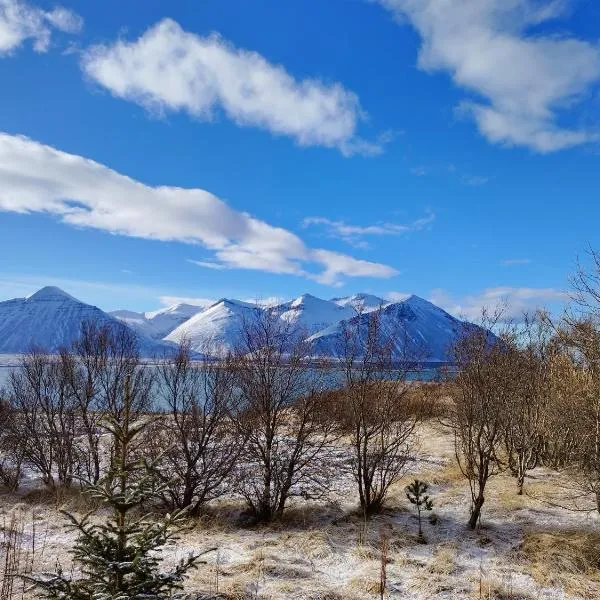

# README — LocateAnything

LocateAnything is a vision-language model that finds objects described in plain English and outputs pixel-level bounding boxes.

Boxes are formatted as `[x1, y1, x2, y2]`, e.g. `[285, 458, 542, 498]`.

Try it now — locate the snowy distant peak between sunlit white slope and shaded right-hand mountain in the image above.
[273, 294, 355, 335]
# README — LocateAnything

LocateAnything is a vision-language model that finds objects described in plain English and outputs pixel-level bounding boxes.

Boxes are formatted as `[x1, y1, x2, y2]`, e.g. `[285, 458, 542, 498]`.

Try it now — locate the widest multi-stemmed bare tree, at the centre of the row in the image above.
[232, 310, 336, 521]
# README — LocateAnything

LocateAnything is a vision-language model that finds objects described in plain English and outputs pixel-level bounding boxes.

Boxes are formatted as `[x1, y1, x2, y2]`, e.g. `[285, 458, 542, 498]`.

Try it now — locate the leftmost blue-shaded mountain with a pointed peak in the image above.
[0, 286, 167, 356]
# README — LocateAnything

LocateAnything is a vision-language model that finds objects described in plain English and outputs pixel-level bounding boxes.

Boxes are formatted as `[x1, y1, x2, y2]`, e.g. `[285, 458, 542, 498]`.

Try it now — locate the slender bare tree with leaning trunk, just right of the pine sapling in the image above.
[451, 314, 506, 529]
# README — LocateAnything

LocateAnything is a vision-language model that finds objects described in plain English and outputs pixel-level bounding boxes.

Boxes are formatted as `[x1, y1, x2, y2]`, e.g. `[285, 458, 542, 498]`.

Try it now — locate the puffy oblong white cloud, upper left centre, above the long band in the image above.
[81, 19, 378, 154]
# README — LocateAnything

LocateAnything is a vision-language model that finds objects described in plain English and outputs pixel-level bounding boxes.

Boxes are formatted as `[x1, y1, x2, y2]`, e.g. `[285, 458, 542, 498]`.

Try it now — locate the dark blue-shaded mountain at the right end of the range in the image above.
[308, 296, 475, 362]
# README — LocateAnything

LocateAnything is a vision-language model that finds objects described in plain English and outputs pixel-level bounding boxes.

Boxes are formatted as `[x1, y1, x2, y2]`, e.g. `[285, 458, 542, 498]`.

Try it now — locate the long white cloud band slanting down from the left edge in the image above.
[0, 133, 397, 285]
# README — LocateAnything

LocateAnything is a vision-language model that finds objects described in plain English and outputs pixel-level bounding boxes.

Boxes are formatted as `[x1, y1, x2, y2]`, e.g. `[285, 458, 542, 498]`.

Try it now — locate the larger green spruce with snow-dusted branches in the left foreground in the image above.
[32, 379, 206, 600]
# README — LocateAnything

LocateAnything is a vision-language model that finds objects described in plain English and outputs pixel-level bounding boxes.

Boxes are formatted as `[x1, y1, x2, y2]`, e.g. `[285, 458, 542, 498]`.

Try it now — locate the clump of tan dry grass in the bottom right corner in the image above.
[521, 530, 600, 598]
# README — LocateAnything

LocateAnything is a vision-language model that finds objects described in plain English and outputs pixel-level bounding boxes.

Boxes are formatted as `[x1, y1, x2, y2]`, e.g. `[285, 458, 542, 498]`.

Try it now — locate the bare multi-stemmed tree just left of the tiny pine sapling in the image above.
[338, 308, 427, 517]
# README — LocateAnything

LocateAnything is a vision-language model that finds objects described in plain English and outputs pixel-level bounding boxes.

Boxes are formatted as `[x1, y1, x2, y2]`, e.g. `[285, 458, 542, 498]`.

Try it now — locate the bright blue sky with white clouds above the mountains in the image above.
[0, 0, 600, 317]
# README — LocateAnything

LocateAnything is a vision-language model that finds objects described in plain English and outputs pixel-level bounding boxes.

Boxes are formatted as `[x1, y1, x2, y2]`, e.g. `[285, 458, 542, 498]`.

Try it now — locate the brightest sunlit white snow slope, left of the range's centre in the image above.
[164, 298, 262, 355]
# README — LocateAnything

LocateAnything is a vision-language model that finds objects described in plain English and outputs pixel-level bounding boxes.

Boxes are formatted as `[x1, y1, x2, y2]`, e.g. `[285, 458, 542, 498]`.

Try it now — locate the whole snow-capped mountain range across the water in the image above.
[0, 286, 473, 362]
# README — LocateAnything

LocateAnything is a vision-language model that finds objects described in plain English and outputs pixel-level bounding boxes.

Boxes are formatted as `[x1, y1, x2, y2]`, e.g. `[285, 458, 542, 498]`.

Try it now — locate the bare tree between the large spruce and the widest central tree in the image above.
[150, 342, 244, 514]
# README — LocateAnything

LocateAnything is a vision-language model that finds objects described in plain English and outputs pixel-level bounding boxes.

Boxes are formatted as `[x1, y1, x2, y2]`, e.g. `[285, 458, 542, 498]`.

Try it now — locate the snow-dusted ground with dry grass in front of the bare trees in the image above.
[0, 423, 600, 600]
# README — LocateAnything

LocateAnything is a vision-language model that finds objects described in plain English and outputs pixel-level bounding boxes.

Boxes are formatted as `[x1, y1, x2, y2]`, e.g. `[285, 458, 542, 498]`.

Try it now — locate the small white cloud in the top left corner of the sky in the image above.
[0, 0, 83, 57]
